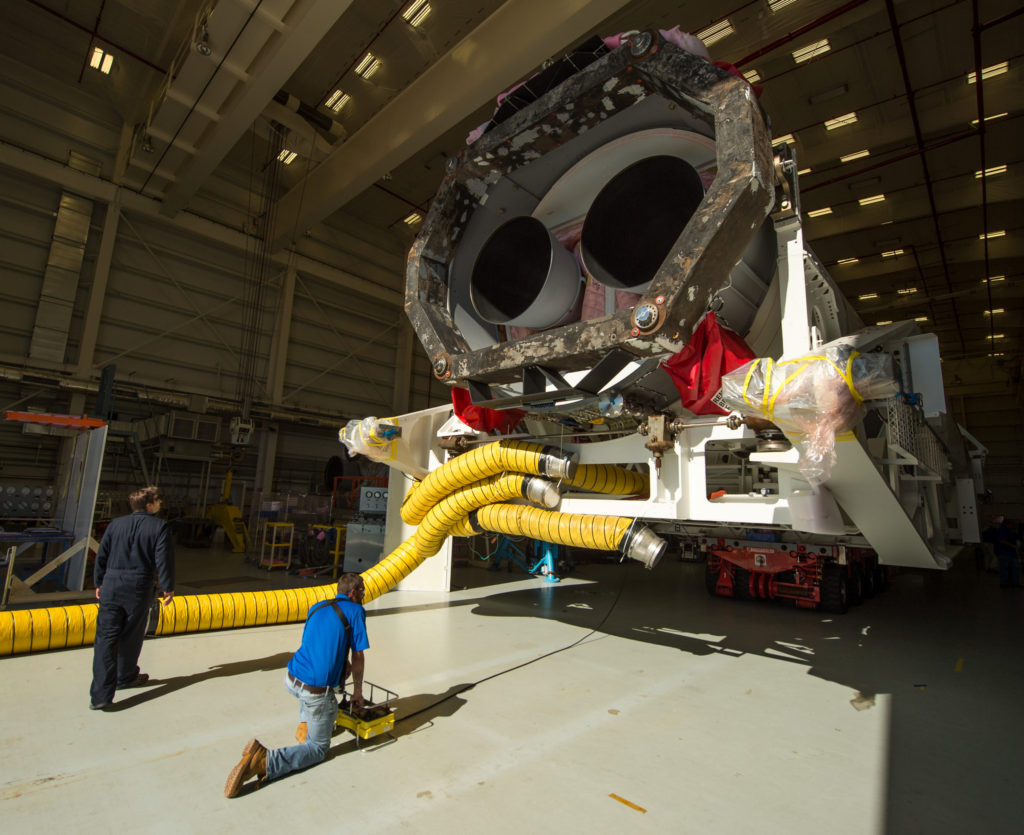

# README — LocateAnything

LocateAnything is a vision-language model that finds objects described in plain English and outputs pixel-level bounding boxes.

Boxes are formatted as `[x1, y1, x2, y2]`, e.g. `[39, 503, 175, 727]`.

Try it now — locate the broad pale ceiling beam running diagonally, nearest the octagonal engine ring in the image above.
[270, 0, 627, 250]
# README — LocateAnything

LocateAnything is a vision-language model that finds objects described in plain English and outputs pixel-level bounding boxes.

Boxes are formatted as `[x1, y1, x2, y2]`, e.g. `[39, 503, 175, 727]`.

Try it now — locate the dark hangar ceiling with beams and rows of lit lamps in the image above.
[0, 0, 1024, 372]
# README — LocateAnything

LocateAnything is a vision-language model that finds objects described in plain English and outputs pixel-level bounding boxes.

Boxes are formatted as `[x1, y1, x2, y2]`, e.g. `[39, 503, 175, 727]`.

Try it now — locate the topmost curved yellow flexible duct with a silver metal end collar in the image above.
[401, 441, 575, 525]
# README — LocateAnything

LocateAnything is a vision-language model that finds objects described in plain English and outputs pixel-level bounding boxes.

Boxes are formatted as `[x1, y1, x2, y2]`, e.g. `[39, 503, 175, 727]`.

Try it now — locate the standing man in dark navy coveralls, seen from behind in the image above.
[89, 486, 174, 710]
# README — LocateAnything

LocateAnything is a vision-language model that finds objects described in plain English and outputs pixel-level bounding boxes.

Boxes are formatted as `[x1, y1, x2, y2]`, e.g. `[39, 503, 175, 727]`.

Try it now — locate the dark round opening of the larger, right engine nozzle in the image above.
[582, 156, 703, 289]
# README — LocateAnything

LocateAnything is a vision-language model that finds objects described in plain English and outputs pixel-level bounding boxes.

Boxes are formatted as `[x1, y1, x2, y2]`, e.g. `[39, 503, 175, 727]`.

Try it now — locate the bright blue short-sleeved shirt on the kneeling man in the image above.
[288, 597, 370, 687]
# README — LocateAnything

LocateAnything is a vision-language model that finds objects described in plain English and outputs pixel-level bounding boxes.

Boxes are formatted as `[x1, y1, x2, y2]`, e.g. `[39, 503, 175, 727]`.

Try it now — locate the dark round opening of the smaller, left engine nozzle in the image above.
[469, 215, 551, 325]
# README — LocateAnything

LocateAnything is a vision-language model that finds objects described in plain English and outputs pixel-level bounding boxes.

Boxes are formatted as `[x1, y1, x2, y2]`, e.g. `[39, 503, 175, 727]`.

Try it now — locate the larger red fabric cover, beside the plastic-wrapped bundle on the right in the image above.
[662, 311, 757, 415]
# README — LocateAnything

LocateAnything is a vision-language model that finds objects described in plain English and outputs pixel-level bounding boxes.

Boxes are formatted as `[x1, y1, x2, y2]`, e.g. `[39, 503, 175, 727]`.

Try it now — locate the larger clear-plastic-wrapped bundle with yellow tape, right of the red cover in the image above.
[715, 342, 898, 485]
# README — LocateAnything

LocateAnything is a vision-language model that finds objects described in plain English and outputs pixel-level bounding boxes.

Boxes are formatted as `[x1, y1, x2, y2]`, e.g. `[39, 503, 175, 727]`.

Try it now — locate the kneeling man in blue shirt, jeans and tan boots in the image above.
[224, 574, 370, 797]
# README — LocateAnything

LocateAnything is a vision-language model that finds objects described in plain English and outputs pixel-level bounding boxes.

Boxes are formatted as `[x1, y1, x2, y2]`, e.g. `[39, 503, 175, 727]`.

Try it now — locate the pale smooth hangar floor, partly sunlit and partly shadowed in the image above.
[0, 549, 1024, 835]
